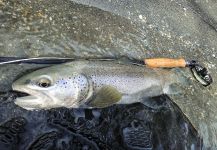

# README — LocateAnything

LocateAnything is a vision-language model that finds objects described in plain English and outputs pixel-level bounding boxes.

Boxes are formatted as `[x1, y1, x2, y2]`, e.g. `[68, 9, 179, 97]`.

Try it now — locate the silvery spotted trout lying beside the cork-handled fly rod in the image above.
[12, 60, 181, 110]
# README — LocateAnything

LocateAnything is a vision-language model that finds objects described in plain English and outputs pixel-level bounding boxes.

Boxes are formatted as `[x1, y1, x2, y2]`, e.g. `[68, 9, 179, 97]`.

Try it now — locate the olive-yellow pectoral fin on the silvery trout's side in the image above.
[88, 86, 122, 108]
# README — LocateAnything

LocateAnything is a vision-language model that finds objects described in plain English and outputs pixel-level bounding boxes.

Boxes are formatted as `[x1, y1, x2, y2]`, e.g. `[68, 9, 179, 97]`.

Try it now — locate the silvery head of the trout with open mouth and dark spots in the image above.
[12, 66, 89, 110]
